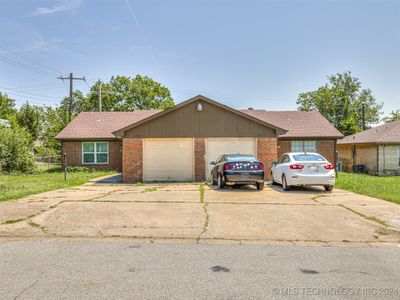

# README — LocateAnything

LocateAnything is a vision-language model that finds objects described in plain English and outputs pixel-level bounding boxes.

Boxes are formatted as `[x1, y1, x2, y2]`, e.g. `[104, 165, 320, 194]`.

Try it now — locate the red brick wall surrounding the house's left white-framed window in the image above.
[62, 141, 122, 171]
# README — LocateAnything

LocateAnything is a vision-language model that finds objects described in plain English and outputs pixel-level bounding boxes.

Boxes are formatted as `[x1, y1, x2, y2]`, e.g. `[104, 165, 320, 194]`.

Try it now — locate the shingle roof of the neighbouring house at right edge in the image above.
[338, 120, 400, 144]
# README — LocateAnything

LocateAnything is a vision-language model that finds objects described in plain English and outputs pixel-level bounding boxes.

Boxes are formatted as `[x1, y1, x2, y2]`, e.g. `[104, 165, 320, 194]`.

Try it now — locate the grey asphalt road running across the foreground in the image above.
[0, 240, 400, 299]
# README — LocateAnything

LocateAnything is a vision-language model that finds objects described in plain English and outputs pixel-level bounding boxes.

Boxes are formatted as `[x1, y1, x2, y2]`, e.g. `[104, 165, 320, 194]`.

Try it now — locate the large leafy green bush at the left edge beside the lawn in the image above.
[0, 127, 36, 173]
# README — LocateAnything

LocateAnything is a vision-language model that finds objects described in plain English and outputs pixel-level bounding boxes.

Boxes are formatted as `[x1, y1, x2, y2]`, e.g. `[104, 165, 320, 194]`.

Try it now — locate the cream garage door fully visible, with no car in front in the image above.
[143, 139, 193, 181]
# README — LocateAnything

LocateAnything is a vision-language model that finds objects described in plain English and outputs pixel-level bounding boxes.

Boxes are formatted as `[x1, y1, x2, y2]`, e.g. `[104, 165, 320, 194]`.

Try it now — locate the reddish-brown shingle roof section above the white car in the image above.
[242, 109, 343, 138]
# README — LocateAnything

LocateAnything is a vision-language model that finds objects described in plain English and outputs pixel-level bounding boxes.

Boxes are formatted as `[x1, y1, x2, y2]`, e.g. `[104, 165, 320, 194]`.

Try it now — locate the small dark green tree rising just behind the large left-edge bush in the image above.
[17, 102, 43, 141]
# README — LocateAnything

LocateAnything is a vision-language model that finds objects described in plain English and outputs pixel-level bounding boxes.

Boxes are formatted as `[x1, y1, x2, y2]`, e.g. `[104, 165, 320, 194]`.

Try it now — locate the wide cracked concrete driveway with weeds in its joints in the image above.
[0, 178, 400, 245]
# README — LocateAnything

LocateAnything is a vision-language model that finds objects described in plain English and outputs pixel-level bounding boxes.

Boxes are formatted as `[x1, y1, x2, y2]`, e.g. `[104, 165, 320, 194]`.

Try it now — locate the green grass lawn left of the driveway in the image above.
[0, 167, 114, 202]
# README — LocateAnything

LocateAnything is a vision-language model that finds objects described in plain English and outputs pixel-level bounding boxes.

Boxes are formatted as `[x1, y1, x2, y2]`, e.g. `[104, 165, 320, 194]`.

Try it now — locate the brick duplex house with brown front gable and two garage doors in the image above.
[57, 96, 343, 182]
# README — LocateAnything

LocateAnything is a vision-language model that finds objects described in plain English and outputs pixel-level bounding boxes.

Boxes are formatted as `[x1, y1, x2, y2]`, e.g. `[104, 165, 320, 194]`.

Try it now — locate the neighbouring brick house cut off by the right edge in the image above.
[338, 120, 400, 175]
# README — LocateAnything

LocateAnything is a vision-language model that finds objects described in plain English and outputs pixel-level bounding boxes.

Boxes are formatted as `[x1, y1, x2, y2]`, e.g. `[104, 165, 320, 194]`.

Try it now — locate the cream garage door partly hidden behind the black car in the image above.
[206, 138, 256, 179]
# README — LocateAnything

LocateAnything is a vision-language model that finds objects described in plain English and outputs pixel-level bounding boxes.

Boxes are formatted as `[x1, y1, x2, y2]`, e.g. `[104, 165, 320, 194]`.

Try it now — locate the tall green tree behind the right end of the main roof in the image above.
[297, 71, 383, 135]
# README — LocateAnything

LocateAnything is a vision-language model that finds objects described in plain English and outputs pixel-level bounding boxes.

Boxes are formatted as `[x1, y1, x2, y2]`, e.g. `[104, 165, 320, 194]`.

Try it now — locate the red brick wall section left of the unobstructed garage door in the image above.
[122, 138, 143, 182]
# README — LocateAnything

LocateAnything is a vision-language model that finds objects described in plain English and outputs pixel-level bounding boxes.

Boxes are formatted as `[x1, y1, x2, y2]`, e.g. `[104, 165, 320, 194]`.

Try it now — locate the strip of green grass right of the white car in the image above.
[335, 173, 400, 204]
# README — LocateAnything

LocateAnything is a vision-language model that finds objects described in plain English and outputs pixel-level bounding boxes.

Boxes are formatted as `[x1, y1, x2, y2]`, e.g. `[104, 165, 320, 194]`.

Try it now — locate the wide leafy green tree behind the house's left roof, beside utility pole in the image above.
[74, 75, 174, 114]
